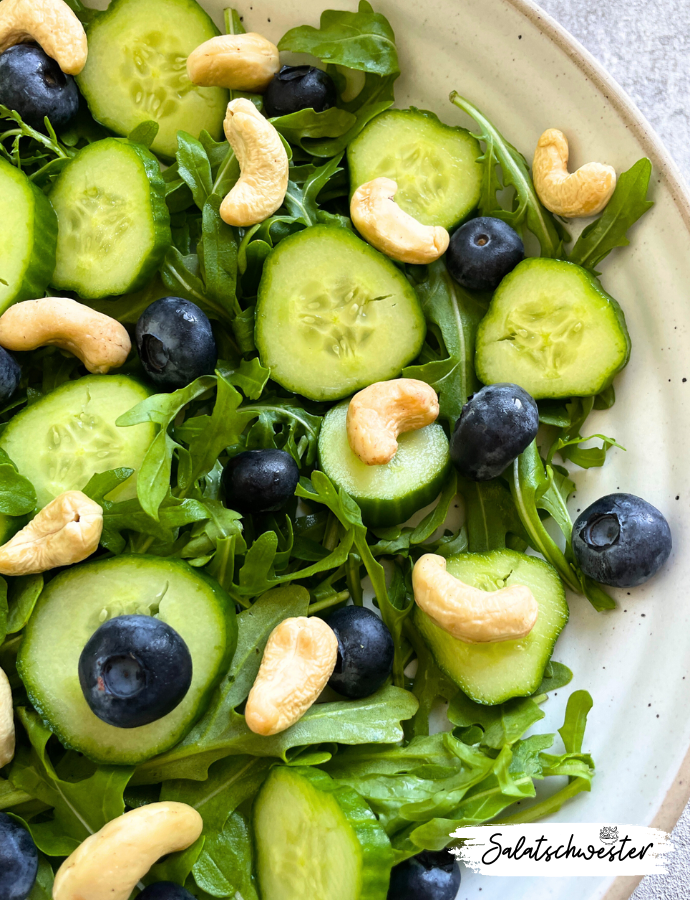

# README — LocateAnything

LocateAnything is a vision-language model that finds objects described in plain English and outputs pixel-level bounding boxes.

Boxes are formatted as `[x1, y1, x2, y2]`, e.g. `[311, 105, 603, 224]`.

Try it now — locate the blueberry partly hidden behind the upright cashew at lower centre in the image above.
[328, 606, 394, 700]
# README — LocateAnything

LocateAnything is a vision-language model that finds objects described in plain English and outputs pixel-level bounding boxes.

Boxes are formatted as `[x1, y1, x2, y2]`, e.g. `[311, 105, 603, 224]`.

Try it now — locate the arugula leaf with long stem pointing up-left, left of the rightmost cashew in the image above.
[450, 91, 569, 259]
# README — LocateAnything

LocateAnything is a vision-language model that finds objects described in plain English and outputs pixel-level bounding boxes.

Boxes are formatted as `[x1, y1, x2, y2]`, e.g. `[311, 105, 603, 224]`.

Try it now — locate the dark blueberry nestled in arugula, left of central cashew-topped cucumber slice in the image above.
[223, 450, 299, 515]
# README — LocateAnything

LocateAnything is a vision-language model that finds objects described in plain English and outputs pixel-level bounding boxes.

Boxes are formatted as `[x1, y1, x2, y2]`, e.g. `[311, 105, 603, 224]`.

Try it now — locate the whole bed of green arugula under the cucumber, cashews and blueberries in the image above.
[0, 0, 651, 900]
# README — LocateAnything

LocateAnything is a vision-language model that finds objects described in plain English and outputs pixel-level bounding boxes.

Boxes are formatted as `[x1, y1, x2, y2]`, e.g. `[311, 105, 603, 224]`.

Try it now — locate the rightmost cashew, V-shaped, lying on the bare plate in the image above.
[532, 128, 616, 219]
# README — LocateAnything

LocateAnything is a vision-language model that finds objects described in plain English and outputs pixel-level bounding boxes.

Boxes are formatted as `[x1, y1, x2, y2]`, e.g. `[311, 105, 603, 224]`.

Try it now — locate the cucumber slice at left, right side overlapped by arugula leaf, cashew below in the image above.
[0, 375, 155, 509]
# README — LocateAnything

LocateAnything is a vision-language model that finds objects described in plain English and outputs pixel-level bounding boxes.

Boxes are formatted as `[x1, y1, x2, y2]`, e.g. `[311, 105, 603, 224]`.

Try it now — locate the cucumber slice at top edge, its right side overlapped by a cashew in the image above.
[77, 0, 228, 159]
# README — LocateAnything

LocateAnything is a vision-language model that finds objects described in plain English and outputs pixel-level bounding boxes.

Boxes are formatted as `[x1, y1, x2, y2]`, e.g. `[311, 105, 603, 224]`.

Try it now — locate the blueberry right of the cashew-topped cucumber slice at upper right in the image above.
[446, 216, 525, 291]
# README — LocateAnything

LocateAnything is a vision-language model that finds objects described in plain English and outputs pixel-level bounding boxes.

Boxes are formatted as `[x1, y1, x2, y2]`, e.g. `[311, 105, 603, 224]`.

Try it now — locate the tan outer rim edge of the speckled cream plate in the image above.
[505, 0, 690, 900]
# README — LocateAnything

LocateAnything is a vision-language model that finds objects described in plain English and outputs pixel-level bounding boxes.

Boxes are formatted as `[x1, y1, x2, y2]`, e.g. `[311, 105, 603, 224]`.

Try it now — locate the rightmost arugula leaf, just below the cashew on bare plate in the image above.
[569, 158, 654, 275]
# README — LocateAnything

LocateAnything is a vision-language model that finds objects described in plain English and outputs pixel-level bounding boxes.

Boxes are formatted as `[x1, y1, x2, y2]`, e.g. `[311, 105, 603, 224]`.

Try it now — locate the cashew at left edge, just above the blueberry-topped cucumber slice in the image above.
[0, 491, 103, 575]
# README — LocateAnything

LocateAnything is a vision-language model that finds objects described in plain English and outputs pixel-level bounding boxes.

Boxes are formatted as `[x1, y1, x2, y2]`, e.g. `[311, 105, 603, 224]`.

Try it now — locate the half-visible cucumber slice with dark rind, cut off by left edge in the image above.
[0, 159, 57, 313]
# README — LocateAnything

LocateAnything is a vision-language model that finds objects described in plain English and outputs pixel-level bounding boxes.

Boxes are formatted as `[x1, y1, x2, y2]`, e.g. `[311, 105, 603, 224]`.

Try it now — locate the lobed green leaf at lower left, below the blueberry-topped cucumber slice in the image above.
[10, 707, 134, 856]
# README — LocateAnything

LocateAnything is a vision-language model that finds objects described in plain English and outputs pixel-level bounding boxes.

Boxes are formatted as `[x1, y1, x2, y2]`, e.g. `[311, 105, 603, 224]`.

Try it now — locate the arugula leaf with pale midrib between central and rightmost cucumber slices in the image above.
[403, 260, 486, 430]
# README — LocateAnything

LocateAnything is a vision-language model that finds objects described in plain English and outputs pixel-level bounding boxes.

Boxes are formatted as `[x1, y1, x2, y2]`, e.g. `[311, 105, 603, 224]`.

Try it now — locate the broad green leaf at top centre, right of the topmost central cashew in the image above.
[278, 0, 400, 75]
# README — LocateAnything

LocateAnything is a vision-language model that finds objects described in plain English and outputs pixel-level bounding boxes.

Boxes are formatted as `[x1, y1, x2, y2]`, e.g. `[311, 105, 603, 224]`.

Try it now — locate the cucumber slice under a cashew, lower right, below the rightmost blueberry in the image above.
[414, 550, 568, 706]
